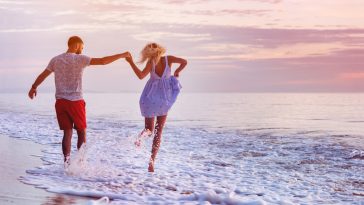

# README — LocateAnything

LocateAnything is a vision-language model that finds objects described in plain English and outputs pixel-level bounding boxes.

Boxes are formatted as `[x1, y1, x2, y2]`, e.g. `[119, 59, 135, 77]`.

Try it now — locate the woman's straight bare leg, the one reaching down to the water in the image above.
[148, 115, 167, 172]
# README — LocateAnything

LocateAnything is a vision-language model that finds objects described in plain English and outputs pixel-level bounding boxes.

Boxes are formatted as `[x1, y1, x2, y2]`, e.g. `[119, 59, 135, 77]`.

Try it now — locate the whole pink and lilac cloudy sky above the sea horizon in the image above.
[0, 0, 364, 92]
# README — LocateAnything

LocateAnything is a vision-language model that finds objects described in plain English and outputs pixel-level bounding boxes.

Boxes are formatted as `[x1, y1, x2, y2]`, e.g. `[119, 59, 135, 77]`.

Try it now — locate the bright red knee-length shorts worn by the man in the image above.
[55, 99, 87, 130]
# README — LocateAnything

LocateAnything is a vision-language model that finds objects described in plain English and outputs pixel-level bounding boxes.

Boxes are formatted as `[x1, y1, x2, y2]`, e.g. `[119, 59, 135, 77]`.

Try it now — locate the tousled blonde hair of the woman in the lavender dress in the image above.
[139, 43, 166, 64]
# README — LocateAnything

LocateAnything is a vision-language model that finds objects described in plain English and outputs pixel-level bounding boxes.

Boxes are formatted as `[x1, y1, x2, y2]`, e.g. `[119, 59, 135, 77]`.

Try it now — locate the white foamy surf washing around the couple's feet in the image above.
[0, 93, 364, 204]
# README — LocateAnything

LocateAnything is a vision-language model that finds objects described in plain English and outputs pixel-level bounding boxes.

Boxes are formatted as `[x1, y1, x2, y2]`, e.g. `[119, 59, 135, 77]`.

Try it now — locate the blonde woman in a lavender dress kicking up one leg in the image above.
[126, 43, 187, 172]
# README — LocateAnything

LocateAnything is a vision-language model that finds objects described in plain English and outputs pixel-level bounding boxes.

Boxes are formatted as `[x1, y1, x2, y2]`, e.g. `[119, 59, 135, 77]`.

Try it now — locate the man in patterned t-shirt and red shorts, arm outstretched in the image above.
[28, 36, 130, 166]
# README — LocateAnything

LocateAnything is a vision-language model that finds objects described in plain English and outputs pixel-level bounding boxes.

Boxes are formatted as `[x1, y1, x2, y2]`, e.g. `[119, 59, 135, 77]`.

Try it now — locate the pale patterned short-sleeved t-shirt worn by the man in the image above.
[46, 53, 91, 101]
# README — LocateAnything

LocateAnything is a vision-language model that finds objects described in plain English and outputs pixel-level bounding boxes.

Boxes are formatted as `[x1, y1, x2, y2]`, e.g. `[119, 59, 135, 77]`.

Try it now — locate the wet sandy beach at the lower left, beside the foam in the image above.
[0, 135, 87, 205]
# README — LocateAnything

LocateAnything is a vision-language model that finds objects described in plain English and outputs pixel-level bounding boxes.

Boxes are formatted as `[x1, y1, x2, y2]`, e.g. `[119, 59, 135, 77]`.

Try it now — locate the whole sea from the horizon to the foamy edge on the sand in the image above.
[0, 93, 364, 204]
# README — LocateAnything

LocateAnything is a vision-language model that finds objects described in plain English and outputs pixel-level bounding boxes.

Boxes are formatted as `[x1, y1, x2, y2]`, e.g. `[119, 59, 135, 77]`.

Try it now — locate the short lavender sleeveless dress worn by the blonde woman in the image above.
[139, 56, 182, 118]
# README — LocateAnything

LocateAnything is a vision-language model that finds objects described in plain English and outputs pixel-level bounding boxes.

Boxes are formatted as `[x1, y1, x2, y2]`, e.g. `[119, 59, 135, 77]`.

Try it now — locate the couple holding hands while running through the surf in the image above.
[28, 36, 187, 172]
